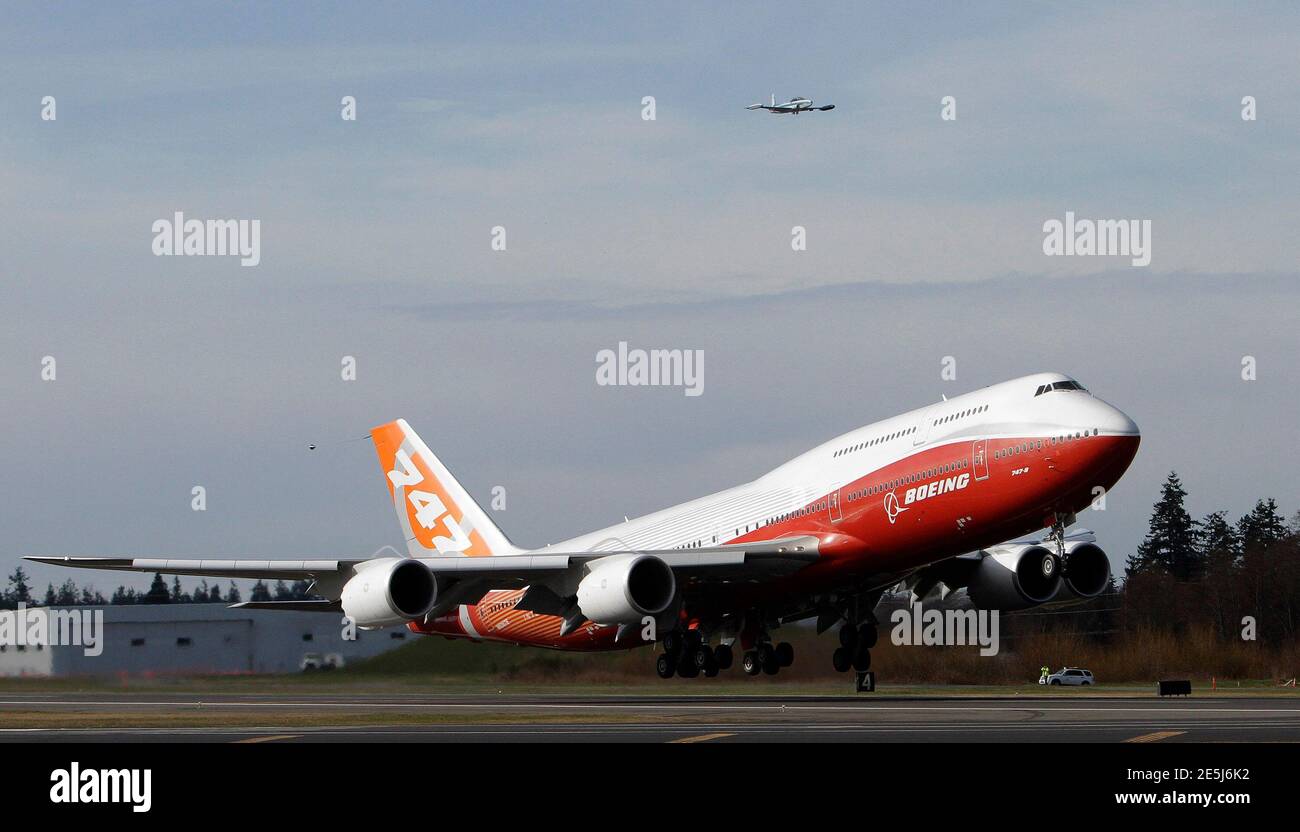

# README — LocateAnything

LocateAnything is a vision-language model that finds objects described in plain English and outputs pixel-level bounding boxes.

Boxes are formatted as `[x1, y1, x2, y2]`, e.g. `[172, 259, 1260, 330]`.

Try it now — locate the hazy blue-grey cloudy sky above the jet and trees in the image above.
[0, 3, 1300, 593]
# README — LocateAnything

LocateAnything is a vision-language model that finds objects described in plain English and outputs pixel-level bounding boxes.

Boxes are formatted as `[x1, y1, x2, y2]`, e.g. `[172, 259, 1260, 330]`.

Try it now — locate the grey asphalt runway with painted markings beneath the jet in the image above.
[0, 693, 1300, 744]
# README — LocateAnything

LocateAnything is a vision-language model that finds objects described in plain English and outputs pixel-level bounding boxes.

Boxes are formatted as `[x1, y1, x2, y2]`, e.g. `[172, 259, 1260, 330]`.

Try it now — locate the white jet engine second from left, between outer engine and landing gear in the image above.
[577, 555, 677, 624]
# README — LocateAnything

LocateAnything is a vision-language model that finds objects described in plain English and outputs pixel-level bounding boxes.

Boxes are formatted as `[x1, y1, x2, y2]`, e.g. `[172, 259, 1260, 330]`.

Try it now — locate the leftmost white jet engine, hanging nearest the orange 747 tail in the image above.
[339, 558, 438, 629]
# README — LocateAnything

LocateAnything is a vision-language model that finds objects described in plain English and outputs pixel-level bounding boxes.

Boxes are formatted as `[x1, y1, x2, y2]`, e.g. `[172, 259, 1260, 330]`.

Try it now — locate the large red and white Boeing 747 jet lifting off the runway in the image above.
[30, 373, 1139, 677]
